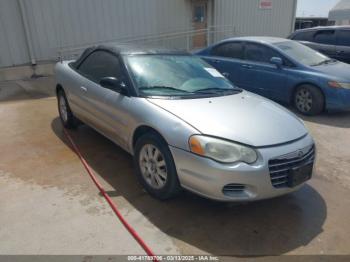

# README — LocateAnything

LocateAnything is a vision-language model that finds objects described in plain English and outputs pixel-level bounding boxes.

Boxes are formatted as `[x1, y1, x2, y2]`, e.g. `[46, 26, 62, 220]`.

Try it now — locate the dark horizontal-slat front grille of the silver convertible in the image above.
[269, 145, 315, 188]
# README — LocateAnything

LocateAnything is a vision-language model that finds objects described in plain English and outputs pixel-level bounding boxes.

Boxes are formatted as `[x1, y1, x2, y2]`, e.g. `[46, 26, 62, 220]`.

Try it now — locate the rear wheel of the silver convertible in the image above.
[57, 90, 78, 129]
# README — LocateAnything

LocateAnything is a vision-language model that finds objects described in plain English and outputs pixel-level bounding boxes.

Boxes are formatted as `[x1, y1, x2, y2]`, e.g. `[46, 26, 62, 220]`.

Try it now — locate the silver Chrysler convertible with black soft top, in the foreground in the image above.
[55, 46, 315, 201]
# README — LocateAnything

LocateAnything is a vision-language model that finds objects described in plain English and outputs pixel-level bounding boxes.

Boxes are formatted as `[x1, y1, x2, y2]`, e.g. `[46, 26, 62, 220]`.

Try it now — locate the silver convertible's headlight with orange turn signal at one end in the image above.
[189, 135, 258, 164]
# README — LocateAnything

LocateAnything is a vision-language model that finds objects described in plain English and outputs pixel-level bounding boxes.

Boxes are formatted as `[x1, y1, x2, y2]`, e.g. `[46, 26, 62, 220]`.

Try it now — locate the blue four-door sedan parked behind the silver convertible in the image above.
[196, 37, 350, 115]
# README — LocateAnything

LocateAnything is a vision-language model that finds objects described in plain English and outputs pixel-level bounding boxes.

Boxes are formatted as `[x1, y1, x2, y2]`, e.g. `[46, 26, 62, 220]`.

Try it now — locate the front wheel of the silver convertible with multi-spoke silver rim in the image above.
[134, 133, 181, 200]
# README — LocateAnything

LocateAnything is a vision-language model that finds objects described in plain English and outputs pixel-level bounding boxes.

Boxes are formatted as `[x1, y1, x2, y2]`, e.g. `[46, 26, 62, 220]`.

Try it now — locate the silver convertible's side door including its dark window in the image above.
[77, 50, 125, 139]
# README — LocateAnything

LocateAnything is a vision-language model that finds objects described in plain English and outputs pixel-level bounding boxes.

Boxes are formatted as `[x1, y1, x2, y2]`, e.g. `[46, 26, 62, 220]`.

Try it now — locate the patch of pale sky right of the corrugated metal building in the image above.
[297, 0, 340, 17]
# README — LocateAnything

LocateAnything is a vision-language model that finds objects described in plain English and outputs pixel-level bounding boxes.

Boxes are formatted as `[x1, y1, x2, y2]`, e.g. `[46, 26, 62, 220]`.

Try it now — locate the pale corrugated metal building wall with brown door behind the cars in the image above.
[0, 0, 297, 68]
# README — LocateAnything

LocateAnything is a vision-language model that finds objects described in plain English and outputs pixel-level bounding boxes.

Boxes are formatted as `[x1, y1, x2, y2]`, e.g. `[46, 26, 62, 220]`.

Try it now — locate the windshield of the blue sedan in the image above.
[274, 41, 333, 66]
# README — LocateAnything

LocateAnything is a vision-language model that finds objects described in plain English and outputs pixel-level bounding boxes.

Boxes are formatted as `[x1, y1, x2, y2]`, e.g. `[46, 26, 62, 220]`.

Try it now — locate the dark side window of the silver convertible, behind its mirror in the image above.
[78, 51, 121, 82]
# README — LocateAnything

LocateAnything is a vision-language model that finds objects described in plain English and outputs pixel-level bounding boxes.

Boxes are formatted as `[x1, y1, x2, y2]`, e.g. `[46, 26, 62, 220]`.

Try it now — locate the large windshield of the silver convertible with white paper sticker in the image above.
[126, 55, 239, 97]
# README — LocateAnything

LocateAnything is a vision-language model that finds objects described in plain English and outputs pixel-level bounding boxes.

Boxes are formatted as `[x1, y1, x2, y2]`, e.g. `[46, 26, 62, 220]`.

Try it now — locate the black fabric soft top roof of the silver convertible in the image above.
[74, 44, 191, 66]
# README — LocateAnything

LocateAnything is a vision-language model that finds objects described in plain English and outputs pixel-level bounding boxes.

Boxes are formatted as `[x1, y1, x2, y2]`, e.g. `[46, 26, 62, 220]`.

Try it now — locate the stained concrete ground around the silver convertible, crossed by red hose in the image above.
[0, 78, 350, 256]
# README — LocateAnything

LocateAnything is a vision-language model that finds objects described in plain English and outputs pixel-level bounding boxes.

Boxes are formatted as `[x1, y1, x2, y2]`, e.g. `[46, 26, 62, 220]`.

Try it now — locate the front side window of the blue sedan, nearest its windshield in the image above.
[245, 43, 283, 63]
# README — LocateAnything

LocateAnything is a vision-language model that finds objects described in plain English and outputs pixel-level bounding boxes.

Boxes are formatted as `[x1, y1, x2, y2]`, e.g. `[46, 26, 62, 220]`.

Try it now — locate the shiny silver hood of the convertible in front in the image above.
[148, 91, 307, 147]
